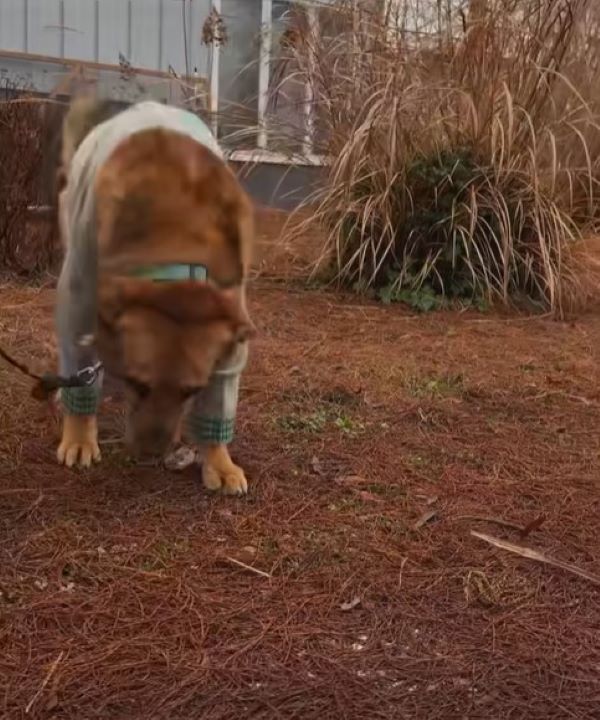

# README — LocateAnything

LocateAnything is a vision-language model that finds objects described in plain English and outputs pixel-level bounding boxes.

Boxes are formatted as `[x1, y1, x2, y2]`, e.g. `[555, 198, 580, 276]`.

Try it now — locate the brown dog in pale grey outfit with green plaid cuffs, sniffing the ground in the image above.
[56, 98, 254, 495]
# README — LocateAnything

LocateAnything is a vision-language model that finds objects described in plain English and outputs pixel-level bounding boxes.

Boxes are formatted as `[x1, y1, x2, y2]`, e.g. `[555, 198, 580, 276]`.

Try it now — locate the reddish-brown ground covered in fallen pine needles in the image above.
[0, 215, 600, 720]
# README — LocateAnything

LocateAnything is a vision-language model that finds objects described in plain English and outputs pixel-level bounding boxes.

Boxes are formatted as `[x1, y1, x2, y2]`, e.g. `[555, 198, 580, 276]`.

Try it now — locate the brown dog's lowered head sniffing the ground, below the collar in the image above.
[97, 277, 253, 455]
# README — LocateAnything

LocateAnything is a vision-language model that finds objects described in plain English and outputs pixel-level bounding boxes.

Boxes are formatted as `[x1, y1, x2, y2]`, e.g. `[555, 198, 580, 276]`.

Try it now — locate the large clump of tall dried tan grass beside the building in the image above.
[284, 0, 600, 314]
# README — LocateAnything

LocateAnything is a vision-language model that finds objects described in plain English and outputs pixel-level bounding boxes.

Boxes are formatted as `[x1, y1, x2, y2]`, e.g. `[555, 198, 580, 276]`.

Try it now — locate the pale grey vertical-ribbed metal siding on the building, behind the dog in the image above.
[0, 0, 211, 74]
